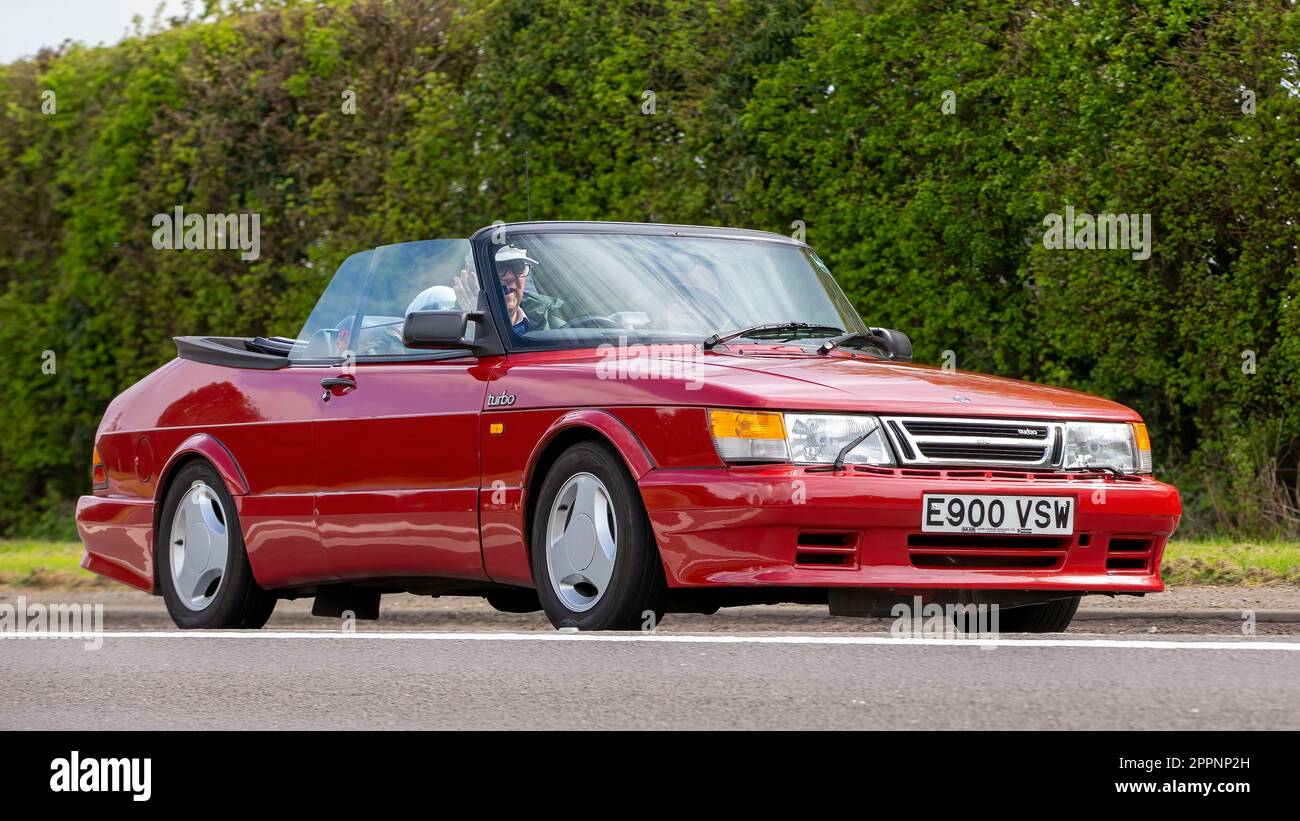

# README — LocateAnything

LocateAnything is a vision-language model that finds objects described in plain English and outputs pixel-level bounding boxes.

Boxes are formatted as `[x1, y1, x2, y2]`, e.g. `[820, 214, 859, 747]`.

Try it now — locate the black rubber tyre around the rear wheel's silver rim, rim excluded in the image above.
[153, 461, 276, 630]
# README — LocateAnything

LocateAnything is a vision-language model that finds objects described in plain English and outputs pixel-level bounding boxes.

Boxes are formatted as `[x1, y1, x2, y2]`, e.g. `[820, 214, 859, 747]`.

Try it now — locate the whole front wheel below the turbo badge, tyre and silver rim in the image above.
[532, 442, 668, 630]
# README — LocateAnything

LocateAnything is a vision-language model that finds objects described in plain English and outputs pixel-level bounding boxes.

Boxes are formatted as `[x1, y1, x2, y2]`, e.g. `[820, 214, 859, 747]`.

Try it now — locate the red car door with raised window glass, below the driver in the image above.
[313, 240, 488, 579]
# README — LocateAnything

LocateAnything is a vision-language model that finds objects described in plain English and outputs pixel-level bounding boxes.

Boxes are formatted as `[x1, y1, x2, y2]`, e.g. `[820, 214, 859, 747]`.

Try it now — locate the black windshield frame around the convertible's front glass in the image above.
[471, 222, 867, 353]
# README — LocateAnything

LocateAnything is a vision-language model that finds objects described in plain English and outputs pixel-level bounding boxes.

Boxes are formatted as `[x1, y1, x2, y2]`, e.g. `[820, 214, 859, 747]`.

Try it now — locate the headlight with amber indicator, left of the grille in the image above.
[709, 411, 893, 465]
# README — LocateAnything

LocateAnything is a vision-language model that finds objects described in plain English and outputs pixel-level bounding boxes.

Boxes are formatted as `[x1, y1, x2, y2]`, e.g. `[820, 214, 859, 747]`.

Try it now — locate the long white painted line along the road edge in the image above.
[0, 630, 1300, 652]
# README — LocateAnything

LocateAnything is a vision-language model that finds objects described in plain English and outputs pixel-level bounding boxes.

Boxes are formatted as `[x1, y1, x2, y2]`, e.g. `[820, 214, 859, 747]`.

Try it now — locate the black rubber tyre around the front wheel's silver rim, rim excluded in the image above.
[529, 442, 668, 630]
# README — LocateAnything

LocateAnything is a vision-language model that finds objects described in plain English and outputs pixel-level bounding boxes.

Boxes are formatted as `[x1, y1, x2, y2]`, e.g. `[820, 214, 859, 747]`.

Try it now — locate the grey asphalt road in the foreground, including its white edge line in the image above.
[0, 630, 1300, 730]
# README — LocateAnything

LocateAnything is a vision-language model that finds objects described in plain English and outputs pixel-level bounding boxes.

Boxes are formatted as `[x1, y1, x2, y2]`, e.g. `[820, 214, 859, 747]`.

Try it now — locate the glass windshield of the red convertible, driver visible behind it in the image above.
[488, 233, 866, 347]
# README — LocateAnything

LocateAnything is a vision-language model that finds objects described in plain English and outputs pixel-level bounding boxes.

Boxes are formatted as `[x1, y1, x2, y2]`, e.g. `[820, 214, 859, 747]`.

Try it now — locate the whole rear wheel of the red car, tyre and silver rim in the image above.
[156, 462, 276, 629]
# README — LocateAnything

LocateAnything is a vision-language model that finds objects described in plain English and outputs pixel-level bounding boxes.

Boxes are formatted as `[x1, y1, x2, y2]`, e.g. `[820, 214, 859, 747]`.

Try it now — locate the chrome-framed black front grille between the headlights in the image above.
[884, 417, 1065, 470]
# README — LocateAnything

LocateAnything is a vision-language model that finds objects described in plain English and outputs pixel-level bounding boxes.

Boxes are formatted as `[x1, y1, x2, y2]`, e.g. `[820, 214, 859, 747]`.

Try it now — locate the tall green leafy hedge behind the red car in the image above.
[0, 0, 1300, 537]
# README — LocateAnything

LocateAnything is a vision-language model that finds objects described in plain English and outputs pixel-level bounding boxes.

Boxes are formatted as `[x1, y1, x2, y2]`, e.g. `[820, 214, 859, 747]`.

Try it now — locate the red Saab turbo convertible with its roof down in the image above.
[77, 222, 1180, 631]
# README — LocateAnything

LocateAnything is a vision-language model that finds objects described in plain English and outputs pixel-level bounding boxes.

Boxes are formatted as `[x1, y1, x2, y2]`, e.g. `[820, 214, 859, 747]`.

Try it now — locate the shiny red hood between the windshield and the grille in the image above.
[705, 352, 1140, 421]
